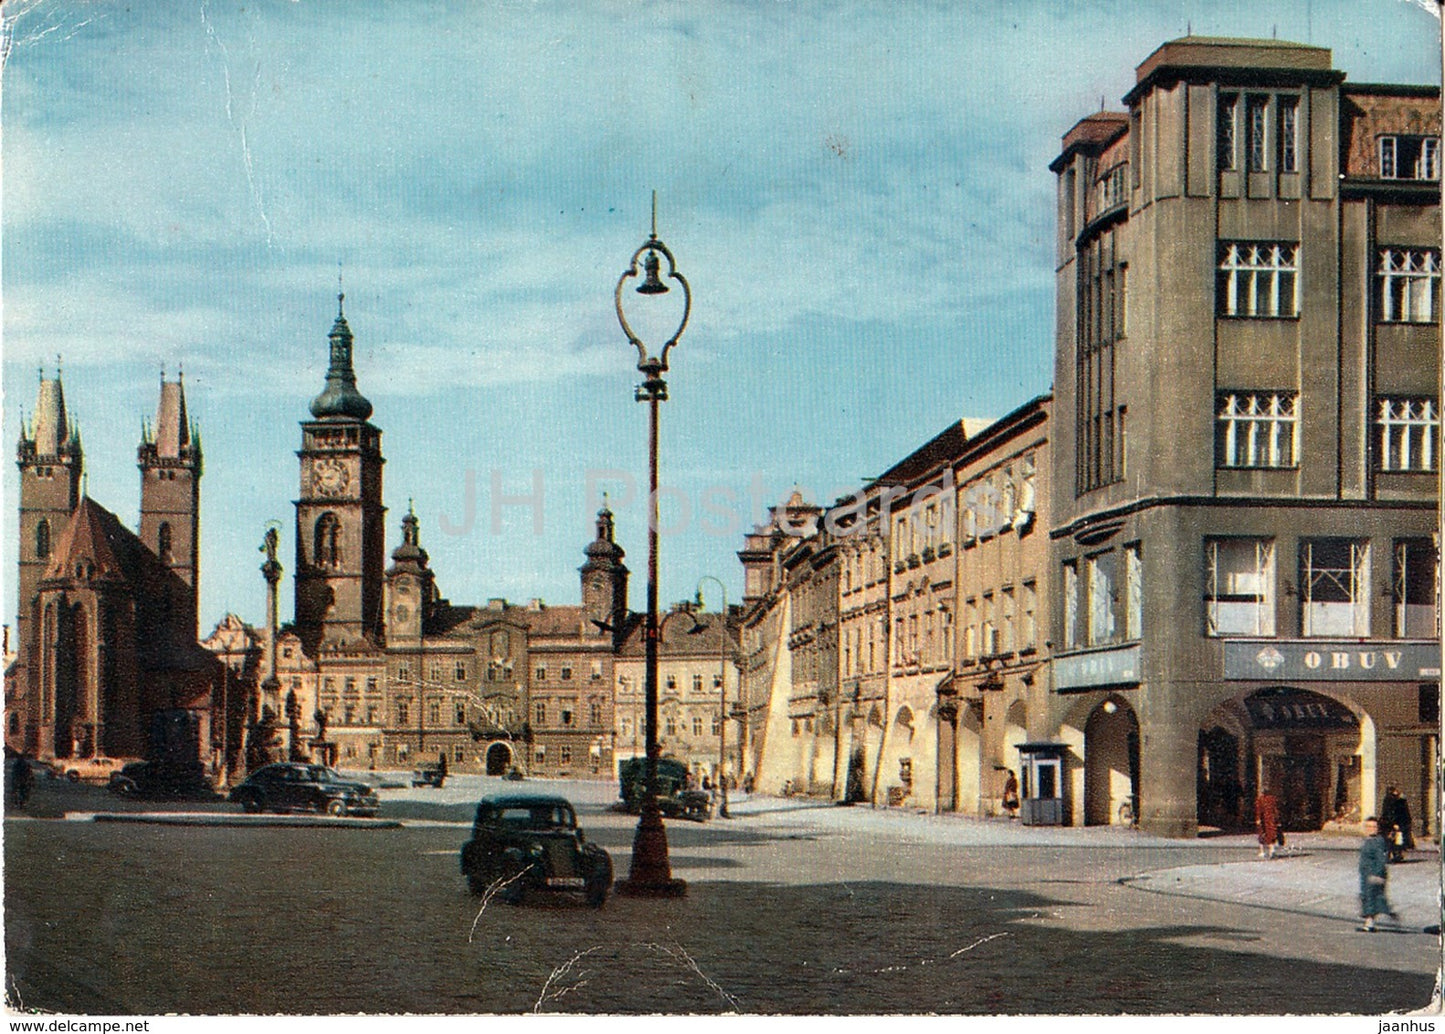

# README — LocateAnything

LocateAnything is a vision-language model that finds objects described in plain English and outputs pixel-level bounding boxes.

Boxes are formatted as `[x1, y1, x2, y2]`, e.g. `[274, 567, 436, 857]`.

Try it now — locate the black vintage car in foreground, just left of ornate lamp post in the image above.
[461, 794, 613, 908]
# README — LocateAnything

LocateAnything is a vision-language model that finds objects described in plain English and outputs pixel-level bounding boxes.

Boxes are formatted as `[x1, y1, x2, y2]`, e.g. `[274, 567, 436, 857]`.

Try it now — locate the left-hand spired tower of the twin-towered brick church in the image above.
[14, 371, 85, 701]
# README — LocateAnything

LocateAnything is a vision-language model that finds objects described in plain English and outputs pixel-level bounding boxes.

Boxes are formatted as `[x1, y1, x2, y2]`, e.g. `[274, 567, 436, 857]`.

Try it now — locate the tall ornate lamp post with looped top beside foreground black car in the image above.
[614, 191, 692, 897]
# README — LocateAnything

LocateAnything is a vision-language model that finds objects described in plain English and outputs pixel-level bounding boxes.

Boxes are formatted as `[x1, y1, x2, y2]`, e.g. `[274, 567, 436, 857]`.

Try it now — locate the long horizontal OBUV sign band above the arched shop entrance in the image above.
[1224, 640, 1441, 682]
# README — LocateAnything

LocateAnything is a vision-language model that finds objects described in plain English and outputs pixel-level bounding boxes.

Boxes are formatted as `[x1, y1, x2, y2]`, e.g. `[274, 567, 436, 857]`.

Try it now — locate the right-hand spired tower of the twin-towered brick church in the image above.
[136, 374, 201, 637]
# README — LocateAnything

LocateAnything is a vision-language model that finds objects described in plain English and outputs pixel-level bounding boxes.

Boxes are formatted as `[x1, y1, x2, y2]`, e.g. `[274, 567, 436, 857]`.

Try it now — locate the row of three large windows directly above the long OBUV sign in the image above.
[1204, 539, 1436, 638]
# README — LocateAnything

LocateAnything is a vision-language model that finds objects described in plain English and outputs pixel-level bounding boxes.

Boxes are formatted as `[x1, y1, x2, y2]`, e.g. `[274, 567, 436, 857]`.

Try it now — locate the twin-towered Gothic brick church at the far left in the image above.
[6, 374, 221, 761]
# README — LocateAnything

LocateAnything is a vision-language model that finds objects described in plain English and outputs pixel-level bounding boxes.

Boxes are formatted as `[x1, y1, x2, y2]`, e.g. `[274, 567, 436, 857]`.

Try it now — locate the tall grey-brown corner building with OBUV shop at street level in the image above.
[1030, 38, 1441, 836]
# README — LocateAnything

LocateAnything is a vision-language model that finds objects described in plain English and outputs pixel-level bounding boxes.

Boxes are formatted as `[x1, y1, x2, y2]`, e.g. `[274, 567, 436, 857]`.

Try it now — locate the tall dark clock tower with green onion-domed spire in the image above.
[296, 295, 386, 654]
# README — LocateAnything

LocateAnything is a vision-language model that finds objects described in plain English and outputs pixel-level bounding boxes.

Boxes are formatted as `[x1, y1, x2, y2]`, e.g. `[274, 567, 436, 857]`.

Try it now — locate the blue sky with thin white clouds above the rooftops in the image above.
[0, 0, 1439, 634]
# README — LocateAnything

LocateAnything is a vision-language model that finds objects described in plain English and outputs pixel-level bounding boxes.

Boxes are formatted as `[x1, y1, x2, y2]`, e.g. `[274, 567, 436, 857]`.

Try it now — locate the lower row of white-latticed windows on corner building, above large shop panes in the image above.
[1215, 391, 1439, 474]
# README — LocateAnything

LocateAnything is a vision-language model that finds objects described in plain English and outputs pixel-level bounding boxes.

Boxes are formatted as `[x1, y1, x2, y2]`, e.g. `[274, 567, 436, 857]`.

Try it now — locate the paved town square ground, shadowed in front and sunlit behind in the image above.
[4, 777, 1441, 1015]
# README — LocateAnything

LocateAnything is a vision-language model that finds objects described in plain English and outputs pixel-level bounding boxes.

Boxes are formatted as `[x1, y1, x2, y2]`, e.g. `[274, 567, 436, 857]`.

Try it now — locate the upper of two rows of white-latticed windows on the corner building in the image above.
[1215, 241, 1441, 323]
